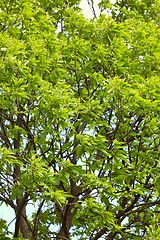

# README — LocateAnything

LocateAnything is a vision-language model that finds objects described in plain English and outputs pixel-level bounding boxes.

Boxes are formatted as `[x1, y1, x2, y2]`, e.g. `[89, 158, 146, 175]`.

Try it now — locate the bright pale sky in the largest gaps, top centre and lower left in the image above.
[0, 0, 115, 236]
